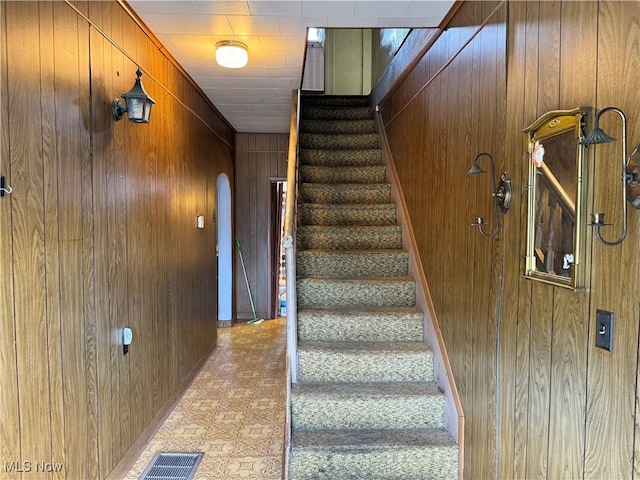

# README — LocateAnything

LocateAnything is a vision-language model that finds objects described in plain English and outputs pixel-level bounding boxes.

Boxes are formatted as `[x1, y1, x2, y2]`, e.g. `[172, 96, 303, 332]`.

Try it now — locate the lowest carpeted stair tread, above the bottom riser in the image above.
[292, 428, 458, 452]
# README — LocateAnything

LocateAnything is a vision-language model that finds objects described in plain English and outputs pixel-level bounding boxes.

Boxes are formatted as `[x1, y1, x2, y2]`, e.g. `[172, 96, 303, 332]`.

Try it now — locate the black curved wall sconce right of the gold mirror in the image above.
[582, 107, 640, 246]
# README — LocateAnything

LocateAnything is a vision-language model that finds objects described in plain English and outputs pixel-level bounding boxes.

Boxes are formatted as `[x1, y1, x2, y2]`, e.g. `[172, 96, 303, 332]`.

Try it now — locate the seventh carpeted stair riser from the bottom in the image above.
[296, 226, 402, 250]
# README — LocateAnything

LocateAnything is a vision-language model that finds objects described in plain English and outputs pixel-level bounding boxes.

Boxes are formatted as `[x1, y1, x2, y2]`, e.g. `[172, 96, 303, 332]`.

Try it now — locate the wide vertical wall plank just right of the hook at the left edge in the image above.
[3, 4, 51, 476]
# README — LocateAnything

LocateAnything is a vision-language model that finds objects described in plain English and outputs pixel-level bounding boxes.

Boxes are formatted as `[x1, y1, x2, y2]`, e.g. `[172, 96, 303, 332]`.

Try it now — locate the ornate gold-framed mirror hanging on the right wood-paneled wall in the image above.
[524, 107, 591, 289]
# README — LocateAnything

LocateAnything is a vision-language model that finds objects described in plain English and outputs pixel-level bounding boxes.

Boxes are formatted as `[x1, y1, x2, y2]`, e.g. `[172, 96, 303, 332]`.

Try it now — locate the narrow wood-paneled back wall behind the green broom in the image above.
[234, 133, 289, 320]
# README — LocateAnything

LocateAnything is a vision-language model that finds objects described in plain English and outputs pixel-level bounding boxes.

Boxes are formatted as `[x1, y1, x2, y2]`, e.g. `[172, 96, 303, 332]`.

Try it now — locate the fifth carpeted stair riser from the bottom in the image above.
[296, 278, 416, 308]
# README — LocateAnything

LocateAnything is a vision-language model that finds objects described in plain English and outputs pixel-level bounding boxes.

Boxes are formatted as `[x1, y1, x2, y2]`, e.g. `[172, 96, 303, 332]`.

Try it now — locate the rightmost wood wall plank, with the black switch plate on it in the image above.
[585, 2, 640, 478]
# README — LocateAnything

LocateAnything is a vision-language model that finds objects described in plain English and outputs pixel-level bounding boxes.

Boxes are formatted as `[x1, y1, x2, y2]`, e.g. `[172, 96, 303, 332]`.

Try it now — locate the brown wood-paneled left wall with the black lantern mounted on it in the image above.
[0, 2, 234, 479]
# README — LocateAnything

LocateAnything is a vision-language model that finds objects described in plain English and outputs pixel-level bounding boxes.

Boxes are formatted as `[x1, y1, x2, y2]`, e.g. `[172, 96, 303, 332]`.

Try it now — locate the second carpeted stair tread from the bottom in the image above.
[292, 381, 442, 399]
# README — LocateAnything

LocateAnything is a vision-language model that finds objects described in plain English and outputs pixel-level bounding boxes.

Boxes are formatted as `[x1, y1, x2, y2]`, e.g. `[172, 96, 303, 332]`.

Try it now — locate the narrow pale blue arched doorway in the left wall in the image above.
[216, 173, 233, 326]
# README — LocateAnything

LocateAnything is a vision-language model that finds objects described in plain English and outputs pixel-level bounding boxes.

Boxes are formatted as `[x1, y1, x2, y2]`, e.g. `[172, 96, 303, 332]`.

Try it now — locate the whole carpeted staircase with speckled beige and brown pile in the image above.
[289, 96, 458, 480]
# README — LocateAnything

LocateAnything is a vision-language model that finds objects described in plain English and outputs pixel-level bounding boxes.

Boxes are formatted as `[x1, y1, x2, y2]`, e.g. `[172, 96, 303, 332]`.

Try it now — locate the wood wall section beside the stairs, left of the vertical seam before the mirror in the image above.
[381, 2, 506, 478]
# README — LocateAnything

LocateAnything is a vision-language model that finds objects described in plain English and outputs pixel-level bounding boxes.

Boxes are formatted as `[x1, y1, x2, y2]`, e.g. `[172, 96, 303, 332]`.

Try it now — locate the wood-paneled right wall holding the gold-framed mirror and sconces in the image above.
[374, 1, 640, 479]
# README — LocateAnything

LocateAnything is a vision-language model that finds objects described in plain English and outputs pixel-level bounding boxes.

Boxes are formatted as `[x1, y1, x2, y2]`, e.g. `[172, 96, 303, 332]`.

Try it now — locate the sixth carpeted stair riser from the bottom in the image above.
[296, 251, 409, 278]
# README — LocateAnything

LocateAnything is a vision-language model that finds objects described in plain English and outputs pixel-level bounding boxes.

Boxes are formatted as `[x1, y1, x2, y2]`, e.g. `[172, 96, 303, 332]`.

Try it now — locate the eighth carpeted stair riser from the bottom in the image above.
[298, 203, 397, 226]
